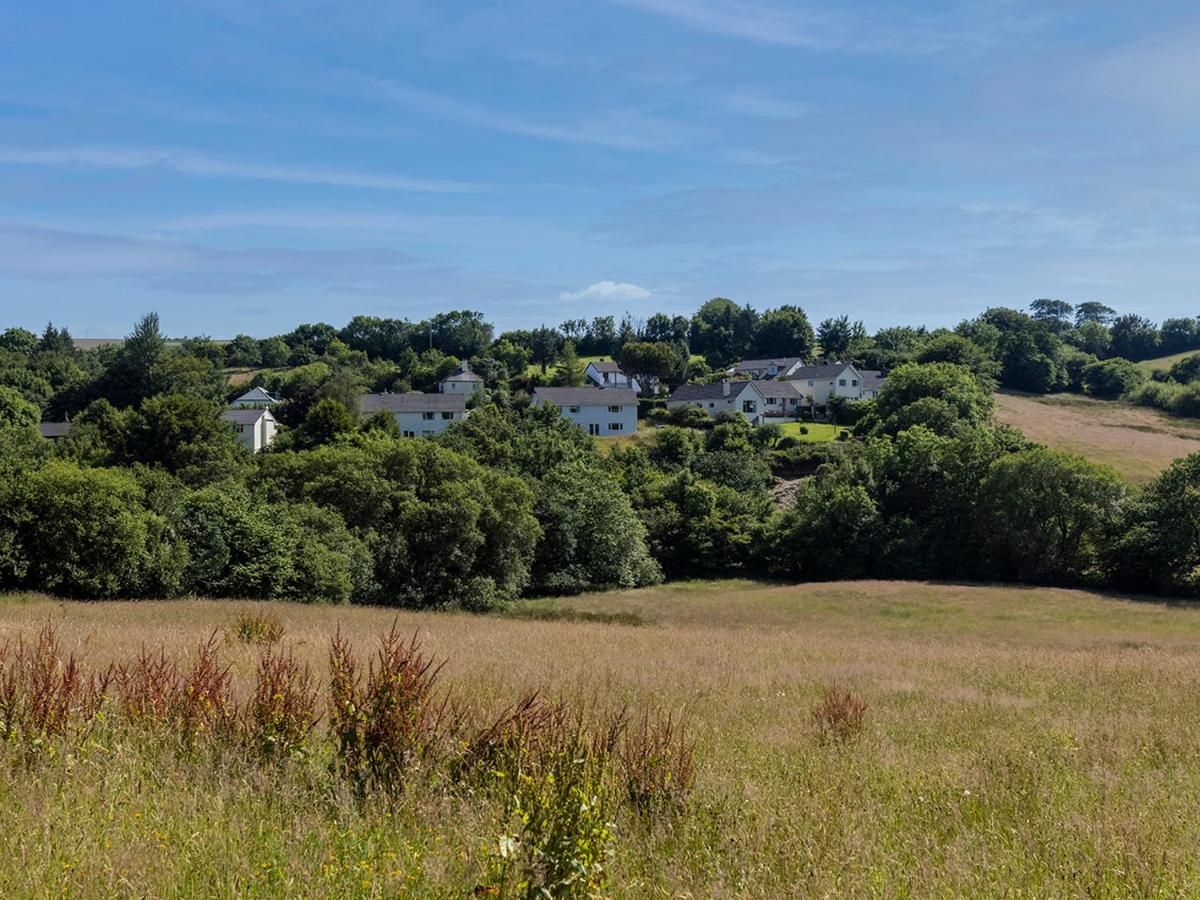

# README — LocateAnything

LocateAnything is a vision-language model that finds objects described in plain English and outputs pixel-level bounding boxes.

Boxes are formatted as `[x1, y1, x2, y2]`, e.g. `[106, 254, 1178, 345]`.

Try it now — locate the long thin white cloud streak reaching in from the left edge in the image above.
[0, 146, 492, 193]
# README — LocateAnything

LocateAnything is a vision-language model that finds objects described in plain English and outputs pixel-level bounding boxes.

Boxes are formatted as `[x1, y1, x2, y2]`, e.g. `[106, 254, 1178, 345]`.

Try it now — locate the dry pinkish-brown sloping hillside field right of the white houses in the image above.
[996, 392, 1200, 482]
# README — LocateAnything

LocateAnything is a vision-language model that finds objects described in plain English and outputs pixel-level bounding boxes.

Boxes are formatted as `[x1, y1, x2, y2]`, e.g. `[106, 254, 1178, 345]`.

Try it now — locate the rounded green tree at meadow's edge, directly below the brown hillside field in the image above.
[978, 448, 1124, 583]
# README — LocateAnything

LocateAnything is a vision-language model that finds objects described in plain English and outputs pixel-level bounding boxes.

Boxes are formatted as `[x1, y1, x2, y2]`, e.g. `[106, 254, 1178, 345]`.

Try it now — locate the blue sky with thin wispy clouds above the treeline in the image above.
[0, 0, 1200, 337]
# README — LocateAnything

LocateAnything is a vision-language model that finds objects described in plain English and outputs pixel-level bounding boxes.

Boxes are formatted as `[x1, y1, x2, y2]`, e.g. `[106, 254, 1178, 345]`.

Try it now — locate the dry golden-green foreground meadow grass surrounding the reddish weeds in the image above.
[0, 582, 1200, 898]
